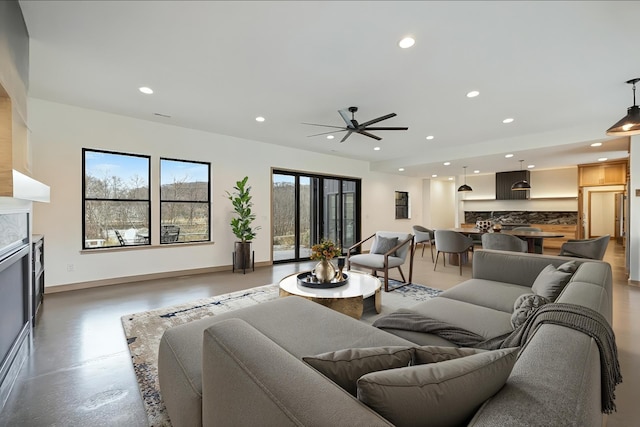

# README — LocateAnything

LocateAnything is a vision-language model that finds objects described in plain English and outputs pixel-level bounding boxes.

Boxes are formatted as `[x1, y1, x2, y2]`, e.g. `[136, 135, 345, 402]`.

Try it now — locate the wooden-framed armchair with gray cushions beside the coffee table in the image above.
[347, 231, 414, 292]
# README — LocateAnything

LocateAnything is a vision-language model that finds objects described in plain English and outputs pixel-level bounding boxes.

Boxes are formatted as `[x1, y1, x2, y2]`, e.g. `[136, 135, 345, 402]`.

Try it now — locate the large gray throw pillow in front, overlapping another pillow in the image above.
[358, 348, 519, 426]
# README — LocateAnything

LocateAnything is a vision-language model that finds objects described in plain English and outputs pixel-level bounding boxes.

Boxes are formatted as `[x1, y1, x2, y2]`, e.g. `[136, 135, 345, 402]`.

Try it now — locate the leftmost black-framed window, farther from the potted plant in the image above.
[82, 149, 151, 249]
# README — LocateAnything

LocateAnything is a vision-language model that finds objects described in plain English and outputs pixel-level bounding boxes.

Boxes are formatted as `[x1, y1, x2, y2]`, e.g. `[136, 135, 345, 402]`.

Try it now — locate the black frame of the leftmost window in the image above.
[81, 147, 153, 250]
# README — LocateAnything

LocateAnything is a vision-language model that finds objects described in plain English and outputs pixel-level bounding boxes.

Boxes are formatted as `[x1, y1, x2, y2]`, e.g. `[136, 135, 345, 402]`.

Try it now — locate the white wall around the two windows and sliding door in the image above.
[29, 99, 422, 287]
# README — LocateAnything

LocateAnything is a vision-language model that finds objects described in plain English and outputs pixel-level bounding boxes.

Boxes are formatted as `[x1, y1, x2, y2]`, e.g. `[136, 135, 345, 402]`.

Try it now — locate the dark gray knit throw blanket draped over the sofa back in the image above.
[373, 303, 622, 414]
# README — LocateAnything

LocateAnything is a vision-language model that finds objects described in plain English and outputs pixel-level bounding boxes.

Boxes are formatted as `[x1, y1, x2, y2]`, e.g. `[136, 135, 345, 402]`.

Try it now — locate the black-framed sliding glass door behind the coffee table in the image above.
[272, 170, 360, 262]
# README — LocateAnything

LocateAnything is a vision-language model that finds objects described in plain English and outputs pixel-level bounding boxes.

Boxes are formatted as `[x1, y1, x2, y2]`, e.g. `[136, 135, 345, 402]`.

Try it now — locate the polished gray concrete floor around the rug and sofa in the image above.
[0, 242, 640, 427]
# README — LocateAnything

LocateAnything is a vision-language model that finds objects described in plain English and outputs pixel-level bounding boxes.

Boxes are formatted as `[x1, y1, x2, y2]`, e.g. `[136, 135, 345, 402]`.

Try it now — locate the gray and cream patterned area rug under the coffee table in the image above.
[121, 280, 442, 427]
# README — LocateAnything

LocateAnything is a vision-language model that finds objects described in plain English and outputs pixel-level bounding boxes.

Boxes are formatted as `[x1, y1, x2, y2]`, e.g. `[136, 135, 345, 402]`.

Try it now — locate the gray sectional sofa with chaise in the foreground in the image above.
[158, 250, 612, 427]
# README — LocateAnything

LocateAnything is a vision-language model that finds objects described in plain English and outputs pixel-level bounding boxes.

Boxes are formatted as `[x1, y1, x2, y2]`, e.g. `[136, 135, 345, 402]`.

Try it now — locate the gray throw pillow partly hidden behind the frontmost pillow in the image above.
[302, 347, 413, 396]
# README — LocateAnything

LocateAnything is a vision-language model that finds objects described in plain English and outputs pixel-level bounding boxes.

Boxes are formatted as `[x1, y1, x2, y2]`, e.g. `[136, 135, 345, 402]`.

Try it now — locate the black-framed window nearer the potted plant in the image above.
[160, 159, 211, 244]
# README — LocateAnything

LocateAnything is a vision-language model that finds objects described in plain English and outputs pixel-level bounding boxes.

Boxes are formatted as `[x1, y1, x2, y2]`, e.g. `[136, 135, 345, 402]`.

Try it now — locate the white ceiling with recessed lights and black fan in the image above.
[20, 0, 640, 177]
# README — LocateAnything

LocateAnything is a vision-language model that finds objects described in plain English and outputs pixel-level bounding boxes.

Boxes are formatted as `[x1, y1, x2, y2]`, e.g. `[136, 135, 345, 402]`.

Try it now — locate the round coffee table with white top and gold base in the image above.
[279, 270, 382, 319]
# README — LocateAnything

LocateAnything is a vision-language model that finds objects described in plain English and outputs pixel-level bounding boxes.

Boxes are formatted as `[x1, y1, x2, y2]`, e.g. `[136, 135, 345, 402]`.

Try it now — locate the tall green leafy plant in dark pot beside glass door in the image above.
[227, 176, 260, 270]
